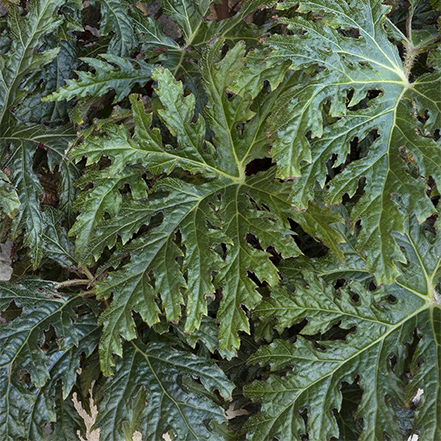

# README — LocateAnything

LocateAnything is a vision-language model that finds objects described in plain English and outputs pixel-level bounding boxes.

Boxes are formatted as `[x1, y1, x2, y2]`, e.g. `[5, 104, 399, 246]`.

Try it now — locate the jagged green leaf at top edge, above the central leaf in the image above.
[48, 0, 275, 110]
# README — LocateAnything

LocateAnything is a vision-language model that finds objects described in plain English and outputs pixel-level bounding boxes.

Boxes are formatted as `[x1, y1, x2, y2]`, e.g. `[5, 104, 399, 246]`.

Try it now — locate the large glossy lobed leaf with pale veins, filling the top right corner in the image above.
[233, 0, 441, 283]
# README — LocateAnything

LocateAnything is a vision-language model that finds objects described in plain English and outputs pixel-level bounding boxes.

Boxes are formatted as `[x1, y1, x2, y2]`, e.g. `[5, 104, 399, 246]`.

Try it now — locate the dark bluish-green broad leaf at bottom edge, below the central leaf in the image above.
[96, 341, 233, 441]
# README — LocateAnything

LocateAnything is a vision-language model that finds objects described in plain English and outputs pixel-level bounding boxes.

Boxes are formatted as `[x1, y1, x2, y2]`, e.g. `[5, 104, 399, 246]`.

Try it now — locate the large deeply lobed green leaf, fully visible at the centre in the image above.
[67, 42, 340, 373]
